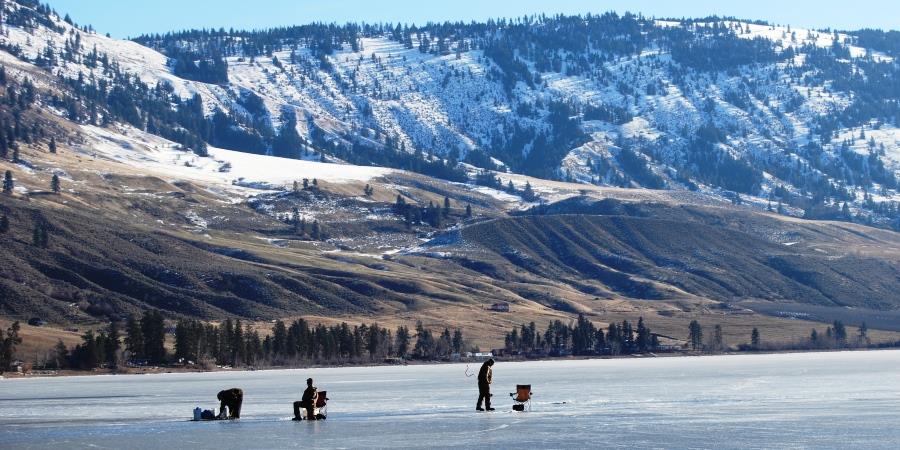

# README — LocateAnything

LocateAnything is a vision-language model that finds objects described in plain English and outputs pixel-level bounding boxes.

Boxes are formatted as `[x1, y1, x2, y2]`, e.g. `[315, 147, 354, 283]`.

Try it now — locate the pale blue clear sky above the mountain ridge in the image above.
[49, 0, 900, 38]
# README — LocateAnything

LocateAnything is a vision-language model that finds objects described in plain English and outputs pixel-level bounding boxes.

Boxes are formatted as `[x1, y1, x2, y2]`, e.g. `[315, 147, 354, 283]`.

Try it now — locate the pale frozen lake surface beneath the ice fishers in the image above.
[0, 351, 900, 449]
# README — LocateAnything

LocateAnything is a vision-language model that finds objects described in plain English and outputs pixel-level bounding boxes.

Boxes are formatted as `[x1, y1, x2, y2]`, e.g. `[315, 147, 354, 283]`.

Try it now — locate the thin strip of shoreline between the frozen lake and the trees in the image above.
[0, 347, 900, 382]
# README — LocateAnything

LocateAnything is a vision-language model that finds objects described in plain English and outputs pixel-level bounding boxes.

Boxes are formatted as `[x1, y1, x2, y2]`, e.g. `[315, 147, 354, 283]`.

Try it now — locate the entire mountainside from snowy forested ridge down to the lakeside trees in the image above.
[0, 0, 900, 352]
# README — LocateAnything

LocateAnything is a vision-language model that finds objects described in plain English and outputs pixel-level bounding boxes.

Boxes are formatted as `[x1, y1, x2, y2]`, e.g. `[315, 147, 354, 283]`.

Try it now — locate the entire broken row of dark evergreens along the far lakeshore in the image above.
[10, 310, 900, 373]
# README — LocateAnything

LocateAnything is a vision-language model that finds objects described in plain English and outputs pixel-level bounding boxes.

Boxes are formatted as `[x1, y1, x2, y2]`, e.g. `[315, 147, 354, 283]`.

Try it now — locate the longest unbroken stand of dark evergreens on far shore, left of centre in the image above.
[48, 310, 470, 370]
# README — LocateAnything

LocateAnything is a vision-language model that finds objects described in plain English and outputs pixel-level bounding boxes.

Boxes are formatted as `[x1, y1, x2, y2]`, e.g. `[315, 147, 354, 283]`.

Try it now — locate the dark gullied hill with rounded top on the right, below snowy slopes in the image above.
[436, 205, 900, 310]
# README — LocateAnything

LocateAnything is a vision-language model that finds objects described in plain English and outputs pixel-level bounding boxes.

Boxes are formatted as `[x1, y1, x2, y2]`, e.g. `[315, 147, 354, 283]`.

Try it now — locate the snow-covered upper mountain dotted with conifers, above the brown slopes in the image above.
[0, 0, 900, 227]
